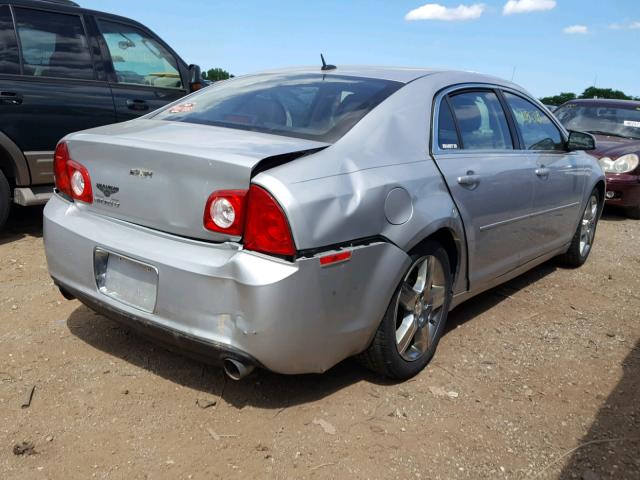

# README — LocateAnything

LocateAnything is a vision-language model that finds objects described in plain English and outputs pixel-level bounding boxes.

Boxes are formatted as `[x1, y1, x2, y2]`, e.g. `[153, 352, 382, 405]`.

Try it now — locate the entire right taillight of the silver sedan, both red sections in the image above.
[204, 185, 296, 256]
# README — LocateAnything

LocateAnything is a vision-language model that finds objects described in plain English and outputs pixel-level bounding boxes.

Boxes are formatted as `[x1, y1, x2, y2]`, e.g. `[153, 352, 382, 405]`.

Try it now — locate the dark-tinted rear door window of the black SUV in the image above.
[15, 8, 94, 80]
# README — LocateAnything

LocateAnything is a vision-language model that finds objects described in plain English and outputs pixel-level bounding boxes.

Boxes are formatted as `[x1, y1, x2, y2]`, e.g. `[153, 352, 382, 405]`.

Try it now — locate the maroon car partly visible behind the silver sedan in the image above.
[553, 99, 640, 219]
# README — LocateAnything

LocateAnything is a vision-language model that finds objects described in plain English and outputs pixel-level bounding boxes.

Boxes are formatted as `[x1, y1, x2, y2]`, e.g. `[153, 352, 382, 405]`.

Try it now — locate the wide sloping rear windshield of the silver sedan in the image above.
[154, 74, 402, 143]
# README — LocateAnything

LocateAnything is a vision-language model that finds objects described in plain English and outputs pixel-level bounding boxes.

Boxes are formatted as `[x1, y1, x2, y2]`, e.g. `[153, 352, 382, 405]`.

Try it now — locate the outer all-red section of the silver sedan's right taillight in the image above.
[244, 185, 296, 256]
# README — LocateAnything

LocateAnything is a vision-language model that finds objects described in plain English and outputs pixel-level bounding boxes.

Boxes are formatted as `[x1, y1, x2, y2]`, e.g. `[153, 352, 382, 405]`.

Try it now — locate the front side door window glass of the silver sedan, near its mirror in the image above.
[504, 92, 564, 151]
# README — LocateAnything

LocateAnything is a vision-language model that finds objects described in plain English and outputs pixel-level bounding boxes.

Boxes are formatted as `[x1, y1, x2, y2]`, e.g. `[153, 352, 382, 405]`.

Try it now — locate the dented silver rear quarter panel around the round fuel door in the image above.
[253, 75, 466, 292]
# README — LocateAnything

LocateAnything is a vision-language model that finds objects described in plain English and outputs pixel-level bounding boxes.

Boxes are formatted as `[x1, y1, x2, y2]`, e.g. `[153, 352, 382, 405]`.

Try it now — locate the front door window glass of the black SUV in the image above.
[98, 20, 183, 88]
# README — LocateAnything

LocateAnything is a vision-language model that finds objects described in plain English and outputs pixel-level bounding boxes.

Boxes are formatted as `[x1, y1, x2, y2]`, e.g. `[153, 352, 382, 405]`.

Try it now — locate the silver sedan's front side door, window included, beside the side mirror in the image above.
[503, 91, 585, 257]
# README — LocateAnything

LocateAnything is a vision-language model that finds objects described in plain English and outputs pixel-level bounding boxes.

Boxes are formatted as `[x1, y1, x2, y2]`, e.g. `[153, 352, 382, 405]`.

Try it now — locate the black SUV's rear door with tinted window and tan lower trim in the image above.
[0, 5, 115, 185]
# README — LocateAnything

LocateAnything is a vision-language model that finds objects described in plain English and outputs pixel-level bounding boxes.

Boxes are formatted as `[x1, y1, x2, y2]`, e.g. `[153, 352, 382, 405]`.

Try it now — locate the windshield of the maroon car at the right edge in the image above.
[554, 102, 640, 140]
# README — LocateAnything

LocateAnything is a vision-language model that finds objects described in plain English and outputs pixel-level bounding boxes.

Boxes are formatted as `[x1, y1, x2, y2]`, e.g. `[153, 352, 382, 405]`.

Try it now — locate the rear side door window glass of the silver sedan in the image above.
[450, 92, 513, 150]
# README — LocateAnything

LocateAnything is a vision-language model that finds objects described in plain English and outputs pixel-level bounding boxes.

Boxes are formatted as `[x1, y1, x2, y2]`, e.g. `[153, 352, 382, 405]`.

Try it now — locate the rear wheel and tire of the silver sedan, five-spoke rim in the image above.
[356, 241, 453, 380]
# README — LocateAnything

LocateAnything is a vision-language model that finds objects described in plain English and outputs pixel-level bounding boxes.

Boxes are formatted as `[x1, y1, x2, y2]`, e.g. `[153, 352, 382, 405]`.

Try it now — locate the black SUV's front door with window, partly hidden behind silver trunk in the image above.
[97, 18, 188, 121]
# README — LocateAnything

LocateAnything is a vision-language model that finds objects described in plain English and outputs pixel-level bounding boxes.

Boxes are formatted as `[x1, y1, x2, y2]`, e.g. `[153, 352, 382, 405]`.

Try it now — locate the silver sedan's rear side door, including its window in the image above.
[432, 88, 535, 290]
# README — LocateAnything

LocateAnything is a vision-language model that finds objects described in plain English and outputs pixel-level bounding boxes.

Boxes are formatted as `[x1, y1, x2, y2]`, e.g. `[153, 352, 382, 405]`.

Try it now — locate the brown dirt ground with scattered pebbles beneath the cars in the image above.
[0, 204, 640, 480]
